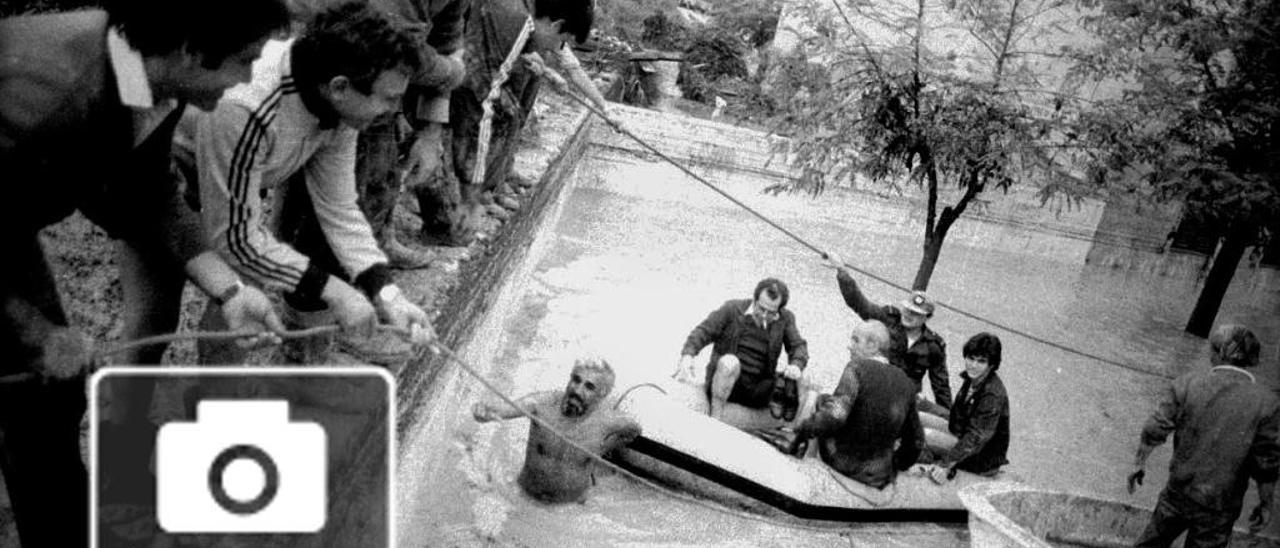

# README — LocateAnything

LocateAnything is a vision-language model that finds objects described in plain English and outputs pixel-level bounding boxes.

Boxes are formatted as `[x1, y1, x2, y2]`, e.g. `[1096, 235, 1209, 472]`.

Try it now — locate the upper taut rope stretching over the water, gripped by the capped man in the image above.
[534, 57, 1174, 379]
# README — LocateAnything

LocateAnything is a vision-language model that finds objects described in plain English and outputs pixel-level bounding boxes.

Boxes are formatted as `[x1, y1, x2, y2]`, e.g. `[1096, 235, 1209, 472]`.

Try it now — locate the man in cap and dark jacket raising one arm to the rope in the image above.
[827, 254, 951, 416]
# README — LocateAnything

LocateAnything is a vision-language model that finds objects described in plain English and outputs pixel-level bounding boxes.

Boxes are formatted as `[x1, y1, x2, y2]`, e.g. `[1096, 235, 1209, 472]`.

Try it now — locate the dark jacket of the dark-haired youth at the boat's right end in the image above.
[947, 371, 1009, 474]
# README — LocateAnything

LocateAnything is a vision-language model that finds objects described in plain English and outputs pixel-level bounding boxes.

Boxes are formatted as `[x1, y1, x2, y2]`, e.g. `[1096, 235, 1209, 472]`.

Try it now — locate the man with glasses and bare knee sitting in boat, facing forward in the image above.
[672, 278, 809, 421]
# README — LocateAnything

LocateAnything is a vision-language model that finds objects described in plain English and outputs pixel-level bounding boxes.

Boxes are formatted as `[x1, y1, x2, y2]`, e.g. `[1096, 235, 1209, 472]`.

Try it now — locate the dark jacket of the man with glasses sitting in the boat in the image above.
[681, 298, 809, 376]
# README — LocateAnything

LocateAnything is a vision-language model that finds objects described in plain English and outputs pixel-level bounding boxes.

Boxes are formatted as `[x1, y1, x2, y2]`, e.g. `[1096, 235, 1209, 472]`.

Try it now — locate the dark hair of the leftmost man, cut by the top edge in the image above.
[102, 0, 289, 69]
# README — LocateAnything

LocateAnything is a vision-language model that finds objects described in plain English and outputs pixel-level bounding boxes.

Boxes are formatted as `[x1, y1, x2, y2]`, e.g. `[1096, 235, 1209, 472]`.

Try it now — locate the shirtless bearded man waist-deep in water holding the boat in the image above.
[471, 357, 640, 502]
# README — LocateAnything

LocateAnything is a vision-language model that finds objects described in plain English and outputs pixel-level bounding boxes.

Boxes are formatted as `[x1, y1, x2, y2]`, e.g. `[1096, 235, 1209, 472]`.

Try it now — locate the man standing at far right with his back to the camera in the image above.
[1129, 325, 1280, 547]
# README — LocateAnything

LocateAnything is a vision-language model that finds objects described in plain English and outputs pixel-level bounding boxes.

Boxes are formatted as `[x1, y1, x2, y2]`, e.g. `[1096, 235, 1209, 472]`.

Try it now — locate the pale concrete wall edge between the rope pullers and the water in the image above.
[394, 97, 594, 544]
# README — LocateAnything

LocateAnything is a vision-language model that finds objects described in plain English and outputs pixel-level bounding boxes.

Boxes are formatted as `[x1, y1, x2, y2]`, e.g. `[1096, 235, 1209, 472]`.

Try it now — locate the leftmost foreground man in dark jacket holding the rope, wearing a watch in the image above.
[0, 0, 288, 547]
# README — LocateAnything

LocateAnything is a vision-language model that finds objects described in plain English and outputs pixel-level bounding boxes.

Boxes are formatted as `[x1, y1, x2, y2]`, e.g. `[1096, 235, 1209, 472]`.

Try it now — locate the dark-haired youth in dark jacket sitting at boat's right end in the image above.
[931, 333, 1009, 483]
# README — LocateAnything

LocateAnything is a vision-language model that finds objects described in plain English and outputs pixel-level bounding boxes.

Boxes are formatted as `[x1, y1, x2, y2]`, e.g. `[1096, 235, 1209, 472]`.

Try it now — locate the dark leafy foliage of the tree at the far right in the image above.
[1078, 0, 1280, 233]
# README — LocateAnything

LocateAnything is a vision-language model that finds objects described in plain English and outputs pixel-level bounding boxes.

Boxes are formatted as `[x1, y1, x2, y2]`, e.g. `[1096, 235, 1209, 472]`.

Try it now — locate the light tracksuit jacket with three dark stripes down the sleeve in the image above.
[195, 41, 387, 292]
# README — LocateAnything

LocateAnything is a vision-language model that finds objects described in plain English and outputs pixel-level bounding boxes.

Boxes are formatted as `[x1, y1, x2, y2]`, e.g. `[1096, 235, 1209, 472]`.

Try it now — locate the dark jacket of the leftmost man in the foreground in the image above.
[0, 10, 209, 261]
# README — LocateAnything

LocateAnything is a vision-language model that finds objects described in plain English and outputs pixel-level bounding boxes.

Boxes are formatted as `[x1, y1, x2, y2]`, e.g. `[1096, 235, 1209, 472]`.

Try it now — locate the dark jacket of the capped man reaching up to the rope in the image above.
[836, 269, 951, 408]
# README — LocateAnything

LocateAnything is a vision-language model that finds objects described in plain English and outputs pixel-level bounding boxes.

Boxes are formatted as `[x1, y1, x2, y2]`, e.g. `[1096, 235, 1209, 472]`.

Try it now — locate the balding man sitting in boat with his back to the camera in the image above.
[791, 320, 924, 489]
